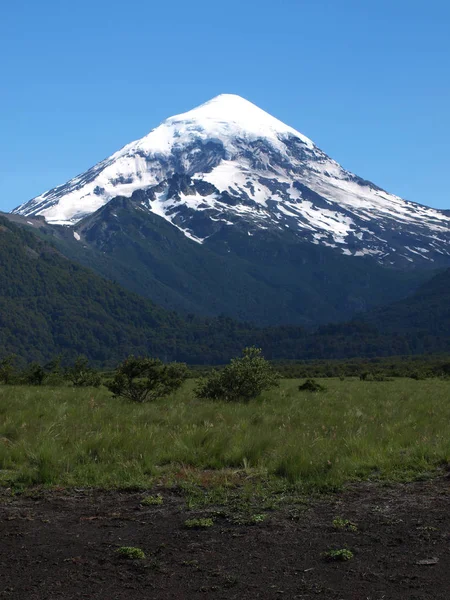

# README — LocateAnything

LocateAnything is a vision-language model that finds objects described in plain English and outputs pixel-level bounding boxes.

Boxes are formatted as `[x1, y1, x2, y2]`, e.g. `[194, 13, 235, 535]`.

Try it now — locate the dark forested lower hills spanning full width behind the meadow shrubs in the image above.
[0, 218, 450, 367]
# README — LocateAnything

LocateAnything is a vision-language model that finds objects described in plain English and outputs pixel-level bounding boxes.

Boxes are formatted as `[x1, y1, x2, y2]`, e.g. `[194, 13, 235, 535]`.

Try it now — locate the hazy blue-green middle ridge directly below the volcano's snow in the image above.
[5, 203, 430, 328]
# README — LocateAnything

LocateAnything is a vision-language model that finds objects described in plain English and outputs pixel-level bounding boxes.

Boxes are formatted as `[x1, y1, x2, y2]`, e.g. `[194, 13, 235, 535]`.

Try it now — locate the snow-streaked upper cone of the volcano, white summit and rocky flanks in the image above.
[13, 94, 450, 264]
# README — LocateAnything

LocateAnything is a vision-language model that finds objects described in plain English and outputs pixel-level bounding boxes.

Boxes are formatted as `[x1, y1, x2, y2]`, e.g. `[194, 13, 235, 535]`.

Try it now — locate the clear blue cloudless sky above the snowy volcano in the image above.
[0, 0, 450, 210]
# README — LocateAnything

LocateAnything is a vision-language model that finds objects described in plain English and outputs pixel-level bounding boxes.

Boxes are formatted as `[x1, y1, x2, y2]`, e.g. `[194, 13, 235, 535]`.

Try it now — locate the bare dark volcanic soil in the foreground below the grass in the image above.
[0, 478, 450, 600]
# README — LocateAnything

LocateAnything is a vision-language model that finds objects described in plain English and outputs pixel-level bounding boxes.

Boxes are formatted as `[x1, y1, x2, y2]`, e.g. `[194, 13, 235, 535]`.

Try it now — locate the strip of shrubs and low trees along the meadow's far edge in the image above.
[0, 346, 450, 403]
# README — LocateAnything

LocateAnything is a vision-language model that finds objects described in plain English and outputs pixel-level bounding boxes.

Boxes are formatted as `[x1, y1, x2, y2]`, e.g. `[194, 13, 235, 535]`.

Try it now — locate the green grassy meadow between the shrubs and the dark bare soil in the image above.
[0, 379, 450, 490]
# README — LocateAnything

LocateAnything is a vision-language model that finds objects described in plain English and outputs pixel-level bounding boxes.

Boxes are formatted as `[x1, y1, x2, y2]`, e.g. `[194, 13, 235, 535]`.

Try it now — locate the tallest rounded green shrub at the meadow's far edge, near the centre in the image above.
[196, 347, 280, 402]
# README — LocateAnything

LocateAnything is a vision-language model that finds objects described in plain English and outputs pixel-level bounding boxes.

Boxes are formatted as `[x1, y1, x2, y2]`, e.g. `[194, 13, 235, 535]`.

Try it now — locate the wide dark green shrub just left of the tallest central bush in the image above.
[106, 356, 188, 402]
